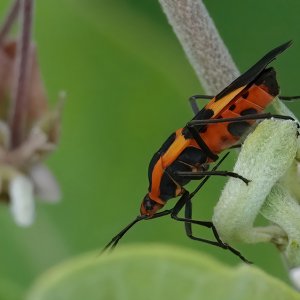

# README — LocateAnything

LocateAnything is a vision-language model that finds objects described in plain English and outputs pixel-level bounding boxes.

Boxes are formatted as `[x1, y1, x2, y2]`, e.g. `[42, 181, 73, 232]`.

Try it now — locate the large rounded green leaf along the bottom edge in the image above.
[27, 245, 300, 300]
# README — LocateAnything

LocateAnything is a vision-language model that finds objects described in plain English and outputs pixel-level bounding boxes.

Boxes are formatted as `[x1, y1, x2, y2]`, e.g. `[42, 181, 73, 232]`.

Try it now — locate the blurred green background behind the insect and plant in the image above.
[0, 0, 300, 296]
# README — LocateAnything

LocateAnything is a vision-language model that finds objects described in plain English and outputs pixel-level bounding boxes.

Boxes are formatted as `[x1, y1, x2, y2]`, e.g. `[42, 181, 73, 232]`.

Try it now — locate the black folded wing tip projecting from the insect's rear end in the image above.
[215, 41, 292, 102]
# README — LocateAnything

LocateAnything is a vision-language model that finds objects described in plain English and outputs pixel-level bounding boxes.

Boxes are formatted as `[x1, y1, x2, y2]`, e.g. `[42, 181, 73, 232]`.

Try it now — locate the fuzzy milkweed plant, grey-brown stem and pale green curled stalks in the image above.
[160, 0, 300, 289]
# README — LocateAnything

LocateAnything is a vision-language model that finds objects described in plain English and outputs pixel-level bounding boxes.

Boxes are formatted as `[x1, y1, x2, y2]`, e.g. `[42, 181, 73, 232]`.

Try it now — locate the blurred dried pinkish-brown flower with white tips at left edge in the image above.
[0, 0, 62, 226]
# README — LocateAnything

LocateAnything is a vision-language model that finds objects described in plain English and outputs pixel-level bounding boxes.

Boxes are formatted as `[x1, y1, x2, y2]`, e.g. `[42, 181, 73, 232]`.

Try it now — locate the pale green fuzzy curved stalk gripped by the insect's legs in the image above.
[213, 119, 297, 243]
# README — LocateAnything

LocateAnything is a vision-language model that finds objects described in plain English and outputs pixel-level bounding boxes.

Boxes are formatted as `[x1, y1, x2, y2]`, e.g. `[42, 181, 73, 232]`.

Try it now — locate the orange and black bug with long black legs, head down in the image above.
[103, 41, 299, 262]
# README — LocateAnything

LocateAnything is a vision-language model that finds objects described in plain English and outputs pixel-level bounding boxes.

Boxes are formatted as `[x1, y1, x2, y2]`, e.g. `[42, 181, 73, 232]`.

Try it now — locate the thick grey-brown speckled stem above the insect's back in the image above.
[159, 0, 239, 94]
